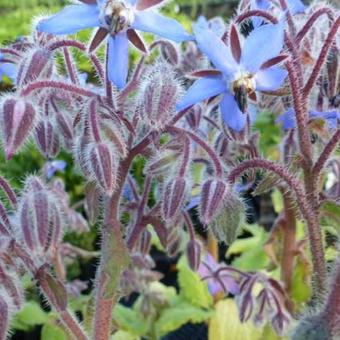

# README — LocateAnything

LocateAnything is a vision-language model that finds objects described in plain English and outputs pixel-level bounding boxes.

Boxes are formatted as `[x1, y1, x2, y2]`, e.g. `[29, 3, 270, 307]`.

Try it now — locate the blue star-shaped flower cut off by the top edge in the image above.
[37, 0, 192, 89]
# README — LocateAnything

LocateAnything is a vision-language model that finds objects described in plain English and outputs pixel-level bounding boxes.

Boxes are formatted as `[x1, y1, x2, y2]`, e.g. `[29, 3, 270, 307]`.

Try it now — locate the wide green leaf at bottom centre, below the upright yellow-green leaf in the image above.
[155, 302, 212, 336]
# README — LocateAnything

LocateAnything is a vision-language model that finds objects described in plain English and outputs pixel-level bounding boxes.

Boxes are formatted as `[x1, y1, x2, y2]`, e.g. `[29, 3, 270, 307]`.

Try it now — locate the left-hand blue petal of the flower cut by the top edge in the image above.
[37, 5, 100, 34]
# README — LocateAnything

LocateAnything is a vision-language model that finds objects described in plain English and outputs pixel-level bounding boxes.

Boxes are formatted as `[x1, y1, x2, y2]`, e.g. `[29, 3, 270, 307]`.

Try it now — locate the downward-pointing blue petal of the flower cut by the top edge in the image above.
[108, 33, 129, 89]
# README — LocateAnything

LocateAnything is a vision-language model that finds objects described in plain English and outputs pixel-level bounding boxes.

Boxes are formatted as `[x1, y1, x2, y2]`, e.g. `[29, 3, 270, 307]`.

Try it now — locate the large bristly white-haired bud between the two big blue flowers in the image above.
[138, 62, 181, 129]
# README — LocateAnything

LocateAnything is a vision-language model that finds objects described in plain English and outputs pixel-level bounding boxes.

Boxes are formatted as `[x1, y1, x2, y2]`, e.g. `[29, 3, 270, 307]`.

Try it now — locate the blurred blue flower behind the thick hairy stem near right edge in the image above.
[276, 108, 340, 130]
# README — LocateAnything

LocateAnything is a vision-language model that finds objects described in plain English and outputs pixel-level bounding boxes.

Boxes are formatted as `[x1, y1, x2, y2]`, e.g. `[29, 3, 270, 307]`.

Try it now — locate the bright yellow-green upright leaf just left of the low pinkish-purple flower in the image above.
[177, 257, 213, 308]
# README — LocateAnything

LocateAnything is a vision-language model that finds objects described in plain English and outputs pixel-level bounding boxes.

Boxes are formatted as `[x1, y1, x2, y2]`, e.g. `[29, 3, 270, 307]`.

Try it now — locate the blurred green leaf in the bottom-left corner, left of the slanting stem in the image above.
[12, 301, 48, 331]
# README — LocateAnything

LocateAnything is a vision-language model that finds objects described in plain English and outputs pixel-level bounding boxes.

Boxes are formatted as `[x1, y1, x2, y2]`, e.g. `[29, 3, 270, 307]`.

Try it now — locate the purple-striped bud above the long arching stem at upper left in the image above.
[17, 48, 53, 86]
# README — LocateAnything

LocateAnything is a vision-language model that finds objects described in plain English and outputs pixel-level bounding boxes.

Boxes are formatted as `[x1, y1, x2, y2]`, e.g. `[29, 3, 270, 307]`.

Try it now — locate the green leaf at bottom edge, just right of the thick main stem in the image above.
[113, 304, 149, 336]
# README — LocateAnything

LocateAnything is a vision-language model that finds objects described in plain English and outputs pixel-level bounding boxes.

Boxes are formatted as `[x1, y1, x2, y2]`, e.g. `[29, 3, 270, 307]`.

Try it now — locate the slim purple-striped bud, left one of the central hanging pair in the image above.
[162, 177, 187, 221]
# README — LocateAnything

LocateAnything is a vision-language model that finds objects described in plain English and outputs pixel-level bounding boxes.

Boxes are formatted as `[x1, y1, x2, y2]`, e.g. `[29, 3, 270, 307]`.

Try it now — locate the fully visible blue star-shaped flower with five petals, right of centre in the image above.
[177, 18, 287, 131]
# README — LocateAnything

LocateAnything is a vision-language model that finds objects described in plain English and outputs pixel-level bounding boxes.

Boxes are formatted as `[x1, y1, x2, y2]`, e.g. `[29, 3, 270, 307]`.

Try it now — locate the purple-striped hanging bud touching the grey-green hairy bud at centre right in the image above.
[200, 179, 229, 225]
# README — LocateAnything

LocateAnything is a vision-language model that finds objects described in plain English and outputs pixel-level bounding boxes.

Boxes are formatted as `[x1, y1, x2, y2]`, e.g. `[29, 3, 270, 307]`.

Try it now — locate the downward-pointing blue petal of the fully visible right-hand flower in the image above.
[220, 92, 247, 131]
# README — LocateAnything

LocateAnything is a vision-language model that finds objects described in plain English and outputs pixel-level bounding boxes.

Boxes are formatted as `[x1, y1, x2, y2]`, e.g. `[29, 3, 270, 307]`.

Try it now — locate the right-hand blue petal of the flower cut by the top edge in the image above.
[131, 10, 193, 42]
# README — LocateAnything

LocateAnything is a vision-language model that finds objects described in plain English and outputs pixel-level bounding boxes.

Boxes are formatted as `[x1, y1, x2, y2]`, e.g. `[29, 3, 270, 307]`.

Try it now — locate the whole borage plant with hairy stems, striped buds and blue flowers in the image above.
[0, 0, 340, 340]
